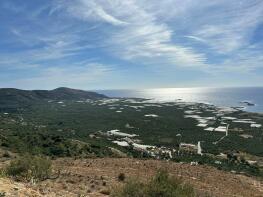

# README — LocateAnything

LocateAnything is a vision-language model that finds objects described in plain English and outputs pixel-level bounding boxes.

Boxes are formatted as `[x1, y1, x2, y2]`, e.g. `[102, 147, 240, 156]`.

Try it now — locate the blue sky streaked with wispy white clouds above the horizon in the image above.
[0, 0, 263, 90]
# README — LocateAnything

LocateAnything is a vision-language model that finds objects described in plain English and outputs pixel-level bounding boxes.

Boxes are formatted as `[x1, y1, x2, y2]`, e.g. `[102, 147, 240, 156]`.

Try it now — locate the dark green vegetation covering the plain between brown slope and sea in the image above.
[0, 99, 263, 177]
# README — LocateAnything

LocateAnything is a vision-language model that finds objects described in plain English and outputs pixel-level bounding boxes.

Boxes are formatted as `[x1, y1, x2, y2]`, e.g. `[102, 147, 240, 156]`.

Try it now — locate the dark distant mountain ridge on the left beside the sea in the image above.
[0, 87, 107, 109]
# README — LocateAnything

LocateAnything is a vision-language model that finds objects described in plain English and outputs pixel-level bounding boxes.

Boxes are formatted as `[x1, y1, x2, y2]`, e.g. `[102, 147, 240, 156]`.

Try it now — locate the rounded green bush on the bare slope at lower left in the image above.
[5, 155, 52, 181]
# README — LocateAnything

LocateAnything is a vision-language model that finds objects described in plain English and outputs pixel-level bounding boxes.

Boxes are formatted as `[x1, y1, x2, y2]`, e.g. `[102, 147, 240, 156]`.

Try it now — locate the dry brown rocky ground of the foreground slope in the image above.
[0, 158, 263, 197]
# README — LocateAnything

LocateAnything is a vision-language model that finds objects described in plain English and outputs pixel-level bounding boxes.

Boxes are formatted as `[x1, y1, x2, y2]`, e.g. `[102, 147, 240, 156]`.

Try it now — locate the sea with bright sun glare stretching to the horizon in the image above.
[97, 87, 263, 113]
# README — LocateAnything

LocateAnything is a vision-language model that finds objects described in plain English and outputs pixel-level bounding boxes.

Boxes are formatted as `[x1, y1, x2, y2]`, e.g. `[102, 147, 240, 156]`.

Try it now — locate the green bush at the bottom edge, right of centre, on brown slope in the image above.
[112, 170, 195, 197]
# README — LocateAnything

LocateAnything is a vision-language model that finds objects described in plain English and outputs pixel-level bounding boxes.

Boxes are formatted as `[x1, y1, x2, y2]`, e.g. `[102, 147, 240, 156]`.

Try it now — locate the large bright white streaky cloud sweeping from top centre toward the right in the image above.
[57, 0, 206, 68]
